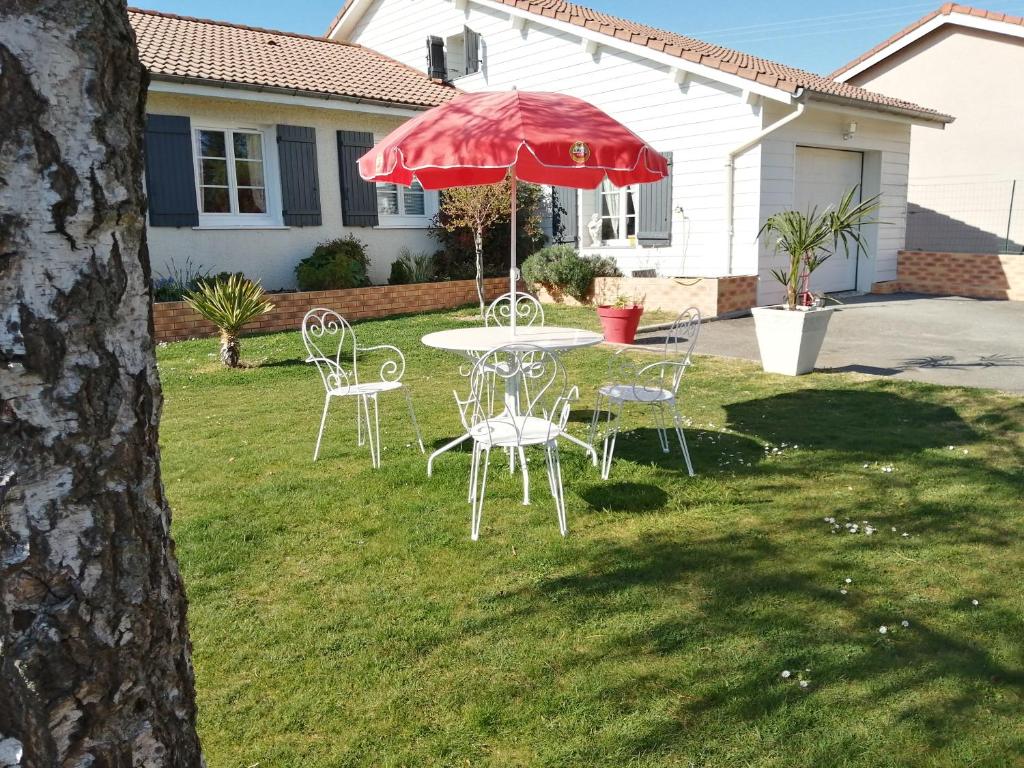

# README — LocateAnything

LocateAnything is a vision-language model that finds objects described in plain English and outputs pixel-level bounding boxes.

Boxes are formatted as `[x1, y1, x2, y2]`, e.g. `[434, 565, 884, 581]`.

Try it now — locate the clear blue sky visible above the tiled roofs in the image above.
[140, 0, 1024, 74]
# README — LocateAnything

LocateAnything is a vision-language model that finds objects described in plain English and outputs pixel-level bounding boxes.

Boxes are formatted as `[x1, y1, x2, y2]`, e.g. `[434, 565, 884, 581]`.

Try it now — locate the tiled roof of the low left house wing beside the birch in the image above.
[128, 8, 458, 106]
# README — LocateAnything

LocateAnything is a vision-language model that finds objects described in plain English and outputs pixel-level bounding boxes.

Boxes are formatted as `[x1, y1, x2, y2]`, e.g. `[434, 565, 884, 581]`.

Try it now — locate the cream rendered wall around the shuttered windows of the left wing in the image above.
[146, 91, 437, 291]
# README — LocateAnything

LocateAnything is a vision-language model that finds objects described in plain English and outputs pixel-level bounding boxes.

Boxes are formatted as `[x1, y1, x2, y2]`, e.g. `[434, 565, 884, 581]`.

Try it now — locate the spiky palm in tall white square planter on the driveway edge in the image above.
[752, 186, 879, 376]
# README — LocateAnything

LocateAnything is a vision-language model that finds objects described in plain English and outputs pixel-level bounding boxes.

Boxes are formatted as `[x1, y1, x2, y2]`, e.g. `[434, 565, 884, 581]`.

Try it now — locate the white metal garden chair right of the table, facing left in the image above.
[590, 307, 700, 480]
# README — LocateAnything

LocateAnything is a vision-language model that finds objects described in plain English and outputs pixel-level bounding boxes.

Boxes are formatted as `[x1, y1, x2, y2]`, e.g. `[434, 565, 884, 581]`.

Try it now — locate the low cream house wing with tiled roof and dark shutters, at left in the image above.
[129, 10, 456, 290]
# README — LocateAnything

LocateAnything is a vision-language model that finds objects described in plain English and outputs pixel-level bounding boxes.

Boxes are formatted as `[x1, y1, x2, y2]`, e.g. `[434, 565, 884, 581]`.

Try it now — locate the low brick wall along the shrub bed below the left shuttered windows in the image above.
[153, 278, 509, 341]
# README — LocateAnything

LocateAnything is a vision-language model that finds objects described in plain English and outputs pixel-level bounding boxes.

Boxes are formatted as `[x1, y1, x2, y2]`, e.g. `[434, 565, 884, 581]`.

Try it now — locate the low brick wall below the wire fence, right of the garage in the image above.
[871, 251, 1024, 301]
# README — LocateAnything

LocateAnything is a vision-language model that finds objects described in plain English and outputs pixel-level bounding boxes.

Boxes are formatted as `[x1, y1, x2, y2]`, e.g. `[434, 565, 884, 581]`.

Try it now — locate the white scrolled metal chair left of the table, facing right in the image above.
[302, 307, 426, 469]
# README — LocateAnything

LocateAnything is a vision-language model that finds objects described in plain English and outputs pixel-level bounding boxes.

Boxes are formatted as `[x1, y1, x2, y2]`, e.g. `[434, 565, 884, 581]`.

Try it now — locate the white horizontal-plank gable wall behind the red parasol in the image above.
[339, 0, 762, 276]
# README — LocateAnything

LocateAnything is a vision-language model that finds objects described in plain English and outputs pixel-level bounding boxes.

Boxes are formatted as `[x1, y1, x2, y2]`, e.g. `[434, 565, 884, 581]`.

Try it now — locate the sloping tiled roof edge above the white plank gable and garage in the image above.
[329, 0, 952, 122]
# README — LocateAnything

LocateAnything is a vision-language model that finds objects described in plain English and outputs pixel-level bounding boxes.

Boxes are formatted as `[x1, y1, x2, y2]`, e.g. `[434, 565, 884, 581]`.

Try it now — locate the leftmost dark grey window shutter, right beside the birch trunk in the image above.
[143, 115, 199, 226]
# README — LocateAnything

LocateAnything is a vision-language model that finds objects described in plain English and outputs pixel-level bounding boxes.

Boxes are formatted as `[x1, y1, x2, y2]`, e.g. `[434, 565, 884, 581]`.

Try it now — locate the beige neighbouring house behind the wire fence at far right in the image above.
[831, 3, 1024, 253]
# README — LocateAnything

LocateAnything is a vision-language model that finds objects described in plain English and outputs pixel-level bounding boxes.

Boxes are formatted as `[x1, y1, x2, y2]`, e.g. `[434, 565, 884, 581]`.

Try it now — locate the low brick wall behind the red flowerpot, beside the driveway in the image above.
[538, 274, 758, 317]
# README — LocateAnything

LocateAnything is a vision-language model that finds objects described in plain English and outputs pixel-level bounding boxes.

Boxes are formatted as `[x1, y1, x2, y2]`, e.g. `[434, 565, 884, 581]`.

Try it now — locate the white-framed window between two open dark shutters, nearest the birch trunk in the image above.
[191, 122, 284, 229]
